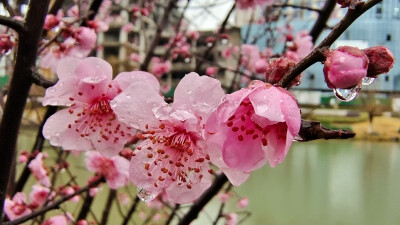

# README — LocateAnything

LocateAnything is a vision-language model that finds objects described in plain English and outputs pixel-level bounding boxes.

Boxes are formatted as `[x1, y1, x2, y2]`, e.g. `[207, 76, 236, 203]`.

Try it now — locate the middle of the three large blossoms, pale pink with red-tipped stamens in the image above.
[112, 73, 224, 203]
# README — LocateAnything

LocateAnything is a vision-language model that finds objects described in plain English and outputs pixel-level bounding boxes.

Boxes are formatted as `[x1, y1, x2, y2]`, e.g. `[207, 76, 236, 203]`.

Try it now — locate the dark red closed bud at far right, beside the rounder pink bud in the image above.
[361, 46, 395, 77]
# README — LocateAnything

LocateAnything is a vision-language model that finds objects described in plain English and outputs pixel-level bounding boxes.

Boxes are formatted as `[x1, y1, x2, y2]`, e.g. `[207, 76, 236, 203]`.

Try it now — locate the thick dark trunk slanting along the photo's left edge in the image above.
[0, 0, 50, 215]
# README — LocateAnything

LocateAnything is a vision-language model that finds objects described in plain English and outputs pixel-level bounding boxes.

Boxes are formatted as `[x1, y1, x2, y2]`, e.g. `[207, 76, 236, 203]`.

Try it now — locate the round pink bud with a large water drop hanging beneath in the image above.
[324, 46, 368, 89]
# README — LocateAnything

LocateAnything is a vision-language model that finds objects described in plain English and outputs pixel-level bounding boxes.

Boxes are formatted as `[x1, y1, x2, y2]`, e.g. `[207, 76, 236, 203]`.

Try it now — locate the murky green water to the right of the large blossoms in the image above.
[231, 141, 400, 225]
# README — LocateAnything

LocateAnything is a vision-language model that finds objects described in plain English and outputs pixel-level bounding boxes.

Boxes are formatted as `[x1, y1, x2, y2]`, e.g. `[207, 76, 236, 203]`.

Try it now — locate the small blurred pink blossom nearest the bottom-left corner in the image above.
[4, 192, 32, 220]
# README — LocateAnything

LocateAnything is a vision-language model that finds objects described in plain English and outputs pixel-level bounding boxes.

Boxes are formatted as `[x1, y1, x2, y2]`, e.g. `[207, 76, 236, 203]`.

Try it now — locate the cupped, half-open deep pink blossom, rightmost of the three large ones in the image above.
[205, 80, 301, 185]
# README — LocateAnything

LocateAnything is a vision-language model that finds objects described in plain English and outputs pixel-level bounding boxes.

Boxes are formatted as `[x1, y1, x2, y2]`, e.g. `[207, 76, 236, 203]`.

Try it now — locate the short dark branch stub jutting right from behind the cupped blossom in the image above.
[299, 120, 356, 141]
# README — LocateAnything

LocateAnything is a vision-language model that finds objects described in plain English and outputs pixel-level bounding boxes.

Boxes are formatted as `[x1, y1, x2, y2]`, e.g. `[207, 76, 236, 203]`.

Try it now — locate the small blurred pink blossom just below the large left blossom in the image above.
[85, 151, 129, 189]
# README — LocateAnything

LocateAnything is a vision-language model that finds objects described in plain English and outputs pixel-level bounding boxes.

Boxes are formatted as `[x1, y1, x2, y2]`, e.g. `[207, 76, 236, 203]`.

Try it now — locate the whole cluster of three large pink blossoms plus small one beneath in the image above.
[37, 57, 300, 204]
